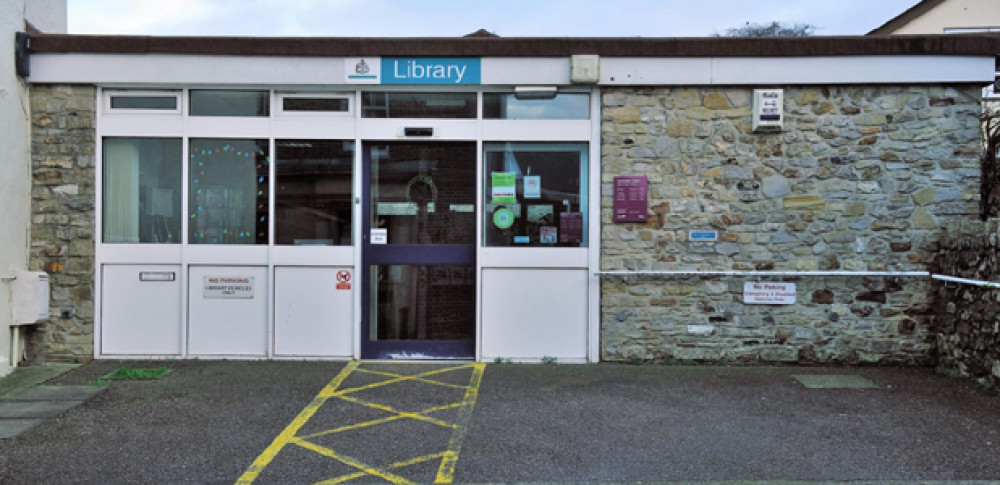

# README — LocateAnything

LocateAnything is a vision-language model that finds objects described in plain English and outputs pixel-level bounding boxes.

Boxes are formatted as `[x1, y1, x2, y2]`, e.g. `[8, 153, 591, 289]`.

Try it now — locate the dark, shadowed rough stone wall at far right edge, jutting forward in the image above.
[933, 220, 1000, 386]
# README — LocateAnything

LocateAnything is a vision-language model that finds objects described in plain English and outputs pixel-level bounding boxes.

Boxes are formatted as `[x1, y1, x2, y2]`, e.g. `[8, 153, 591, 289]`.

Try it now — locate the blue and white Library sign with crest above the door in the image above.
[344, 57, 482, 85]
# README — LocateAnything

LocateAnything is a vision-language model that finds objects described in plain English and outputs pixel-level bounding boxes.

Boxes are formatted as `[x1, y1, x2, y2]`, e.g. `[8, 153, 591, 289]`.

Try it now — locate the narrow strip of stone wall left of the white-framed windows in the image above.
[29, 85, 95, 359]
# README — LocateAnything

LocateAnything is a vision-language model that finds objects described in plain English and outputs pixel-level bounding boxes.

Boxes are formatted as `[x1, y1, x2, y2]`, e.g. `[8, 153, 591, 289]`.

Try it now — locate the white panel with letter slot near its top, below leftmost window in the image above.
[100, 265, 182, 355]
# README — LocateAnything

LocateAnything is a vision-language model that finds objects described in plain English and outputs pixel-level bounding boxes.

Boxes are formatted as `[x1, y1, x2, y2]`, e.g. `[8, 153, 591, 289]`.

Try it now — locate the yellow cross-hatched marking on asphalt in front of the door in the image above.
[236, 362, 486, 484]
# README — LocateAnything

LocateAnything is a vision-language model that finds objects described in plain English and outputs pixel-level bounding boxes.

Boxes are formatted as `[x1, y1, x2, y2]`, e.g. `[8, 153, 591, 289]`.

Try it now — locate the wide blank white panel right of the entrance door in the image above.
[482, 269, 588, 362]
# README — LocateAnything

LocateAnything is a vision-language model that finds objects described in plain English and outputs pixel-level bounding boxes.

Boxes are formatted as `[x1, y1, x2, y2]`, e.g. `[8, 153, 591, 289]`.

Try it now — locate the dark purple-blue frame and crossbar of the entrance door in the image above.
[359, 142, 476, 360]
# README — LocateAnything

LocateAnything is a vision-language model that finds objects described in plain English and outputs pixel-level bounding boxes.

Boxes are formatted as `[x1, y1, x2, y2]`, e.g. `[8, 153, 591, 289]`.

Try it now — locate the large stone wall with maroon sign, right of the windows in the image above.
[601, 86, 980, 364]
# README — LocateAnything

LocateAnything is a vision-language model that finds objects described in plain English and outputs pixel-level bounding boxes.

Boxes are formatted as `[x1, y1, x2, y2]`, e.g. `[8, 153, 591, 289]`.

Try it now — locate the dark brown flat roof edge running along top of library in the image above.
[31, 34, 1000, 57]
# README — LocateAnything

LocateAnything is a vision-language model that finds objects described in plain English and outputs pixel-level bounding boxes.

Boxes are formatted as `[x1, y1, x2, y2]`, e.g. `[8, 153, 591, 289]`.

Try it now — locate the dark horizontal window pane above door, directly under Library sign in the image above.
[361, 93, 476, 118]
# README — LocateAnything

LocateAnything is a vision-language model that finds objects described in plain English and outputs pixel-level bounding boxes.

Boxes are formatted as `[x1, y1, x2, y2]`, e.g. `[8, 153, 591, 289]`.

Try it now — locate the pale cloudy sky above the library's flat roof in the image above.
[67, 0, 919, 37]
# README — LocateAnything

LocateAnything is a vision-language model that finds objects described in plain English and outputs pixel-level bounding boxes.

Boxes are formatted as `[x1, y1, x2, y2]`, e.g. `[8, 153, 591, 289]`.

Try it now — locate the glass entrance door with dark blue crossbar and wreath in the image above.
[361, 141, 476, 359]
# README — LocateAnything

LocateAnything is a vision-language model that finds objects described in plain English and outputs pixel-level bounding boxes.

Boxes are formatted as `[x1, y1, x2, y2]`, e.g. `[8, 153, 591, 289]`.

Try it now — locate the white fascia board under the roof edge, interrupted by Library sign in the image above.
[28, 54, 995, 86]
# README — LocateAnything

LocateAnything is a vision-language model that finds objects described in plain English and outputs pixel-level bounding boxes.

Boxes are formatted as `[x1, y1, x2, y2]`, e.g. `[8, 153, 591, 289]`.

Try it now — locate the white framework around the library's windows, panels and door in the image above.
[94, 85, 601, 361]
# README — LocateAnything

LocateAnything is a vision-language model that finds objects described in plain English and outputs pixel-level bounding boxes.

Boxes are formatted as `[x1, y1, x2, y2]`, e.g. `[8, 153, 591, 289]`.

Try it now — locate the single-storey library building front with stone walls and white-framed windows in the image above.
[19, 35, 1000, 363]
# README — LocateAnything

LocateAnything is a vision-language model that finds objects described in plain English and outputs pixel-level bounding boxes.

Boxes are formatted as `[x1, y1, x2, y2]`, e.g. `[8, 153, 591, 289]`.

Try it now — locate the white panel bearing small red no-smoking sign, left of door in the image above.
[274, 266, 357, 358]
